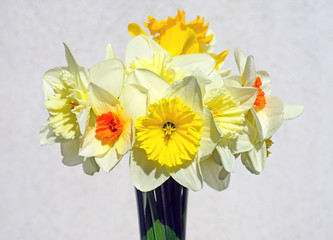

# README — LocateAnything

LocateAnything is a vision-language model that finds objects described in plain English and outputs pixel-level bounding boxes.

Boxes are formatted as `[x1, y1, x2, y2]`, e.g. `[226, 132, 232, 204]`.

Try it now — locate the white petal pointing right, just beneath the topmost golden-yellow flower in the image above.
[173, 53, 215, 75]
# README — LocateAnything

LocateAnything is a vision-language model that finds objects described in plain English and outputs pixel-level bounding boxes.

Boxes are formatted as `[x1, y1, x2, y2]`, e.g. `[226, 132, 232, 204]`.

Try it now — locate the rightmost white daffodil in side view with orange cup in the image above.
[232, 48, 304, 174]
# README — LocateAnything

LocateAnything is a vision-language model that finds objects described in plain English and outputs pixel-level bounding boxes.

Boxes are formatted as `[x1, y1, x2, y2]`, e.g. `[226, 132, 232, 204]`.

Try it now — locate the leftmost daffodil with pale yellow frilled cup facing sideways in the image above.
[40, 44, 99, 175]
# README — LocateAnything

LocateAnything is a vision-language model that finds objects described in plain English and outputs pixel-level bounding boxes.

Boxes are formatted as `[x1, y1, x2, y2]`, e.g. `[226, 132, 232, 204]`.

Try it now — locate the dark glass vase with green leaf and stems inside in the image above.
[136, 177, 188, 240]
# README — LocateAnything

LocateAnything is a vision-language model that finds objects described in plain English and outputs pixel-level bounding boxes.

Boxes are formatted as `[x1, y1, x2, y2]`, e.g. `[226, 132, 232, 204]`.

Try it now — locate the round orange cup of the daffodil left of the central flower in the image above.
[95, 112, 124, 143]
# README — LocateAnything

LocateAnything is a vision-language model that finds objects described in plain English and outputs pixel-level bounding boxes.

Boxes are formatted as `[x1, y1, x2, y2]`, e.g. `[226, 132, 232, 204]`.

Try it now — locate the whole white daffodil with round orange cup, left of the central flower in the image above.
[80, 59, 147, 172]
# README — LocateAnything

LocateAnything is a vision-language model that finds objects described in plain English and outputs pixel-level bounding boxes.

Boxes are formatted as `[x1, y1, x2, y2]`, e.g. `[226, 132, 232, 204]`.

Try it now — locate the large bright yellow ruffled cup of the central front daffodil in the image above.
[135, 98, 203, 168]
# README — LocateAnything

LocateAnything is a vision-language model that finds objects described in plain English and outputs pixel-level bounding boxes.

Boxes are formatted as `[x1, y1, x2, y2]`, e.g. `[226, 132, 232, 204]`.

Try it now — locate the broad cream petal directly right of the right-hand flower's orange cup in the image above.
[256, 96, 284, 139]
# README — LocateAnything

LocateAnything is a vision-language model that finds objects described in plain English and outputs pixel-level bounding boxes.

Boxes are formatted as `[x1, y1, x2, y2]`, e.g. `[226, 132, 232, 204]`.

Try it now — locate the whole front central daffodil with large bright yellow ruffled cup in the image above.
[127, 69, 221, 191]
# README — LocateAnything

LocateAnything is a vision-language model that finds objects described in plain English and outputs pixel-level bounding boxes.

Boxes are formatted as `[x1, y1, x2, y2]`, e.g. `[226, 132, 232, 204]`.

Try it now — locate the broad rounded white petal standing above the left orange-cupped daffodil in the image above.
[89, 59, 125, 97]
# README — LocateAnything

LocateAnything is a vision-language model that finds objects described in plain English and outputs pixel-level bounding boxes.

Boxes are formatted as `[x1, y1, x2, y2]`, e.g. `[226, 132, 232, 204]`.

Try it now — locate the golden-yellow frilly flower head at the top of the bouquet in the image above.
[128, 10, 213, 56]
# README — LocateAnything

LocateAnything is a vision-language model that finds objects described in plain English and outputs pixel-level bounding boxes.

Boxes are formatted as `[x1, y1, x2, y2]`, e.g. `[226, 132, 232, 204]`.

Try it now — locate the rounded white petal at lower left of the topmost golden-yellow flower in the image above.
[125, 35, 166, 65]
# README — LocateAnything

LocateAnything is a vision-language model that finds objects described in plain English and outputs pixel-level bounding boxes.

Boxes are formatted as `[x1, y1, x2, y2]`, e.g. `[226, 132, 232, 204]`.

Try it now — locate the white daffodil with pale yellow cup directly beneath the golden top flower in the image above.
[125, 35, 216, 94]
